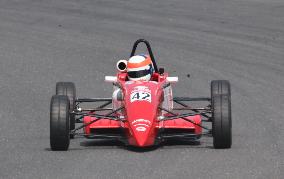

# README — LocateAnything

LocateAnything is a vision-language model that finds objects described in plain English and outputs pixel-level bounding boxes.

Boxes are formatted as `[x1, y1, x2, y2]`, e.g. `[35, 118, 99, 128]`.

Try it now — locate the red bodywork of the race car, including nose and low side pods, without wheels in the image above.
[84, 73, 202, 147]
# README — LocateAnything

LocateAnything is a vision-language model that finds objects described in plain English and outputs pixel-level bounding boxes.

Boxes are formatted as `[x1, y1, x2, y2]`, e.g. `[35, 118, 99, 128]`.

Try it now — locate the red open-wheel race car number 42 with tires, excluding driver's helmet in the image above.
[50, 39, 232, 150]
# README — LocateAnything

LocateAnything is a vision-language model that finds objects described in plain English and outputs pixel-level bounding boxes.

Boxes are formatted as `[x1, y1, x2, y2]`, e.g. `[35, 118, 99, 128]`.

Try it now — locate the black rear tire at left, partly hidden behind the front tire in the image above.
[56, 82, 76, 139]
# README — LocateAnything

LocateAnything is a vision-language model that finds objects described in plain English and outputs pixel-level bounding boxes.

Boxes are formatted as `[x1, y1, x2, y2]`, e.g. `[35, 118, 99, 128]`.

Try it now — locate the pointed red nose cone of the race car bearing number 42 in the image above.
[124, 81, 162, 147]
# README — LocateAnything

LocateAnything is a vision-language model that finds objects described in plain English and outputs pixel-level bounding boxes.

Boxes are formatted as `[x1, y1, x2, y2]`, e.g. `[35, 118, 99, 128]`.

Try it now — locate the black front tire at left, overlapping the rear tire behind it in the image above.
[50, 95, 70, 151]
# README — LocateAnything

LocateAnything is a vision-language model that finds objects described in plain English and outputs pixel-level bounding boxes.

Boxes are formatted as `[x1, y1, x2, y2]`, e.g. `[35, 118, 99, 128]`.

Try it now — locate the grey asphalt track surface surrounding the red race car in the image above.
[0, 0, 284, 179]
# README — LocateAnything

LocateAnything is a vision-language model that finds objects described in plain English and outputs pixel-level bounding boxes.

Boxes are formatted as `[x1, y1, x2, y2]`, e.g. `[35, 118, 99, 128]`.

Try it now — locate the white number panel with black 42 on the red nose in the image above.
[130, 86, 152, 103]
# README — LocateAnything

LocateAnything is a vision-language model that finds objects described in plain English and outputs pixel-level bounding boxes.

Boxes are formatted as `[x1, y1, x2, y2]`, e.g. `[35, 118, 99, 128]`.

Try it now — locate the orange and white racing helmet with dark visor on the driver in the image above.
[127, 54, 154, 81]
